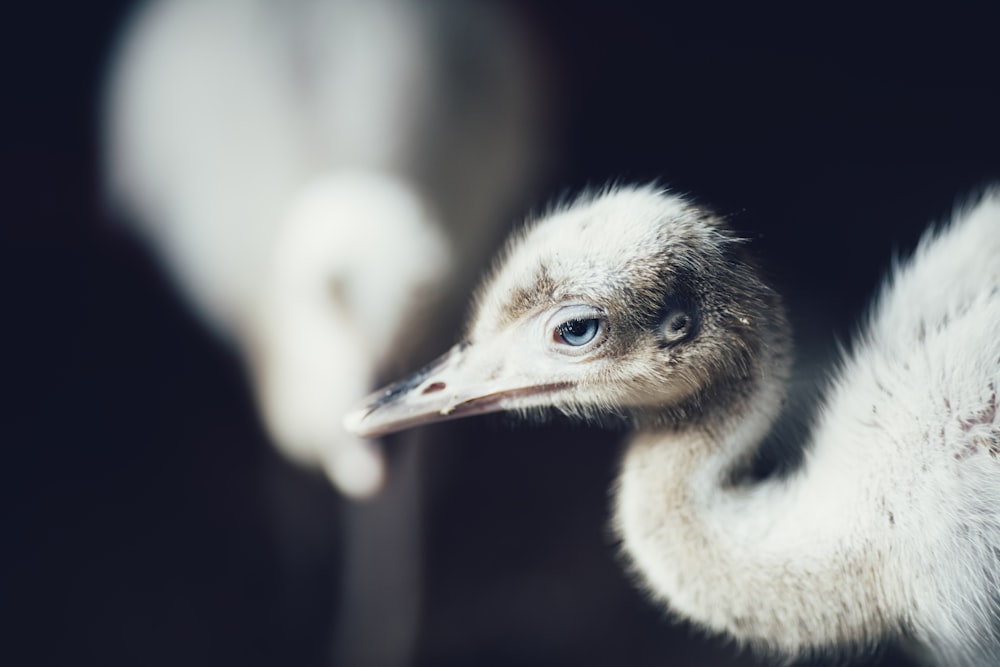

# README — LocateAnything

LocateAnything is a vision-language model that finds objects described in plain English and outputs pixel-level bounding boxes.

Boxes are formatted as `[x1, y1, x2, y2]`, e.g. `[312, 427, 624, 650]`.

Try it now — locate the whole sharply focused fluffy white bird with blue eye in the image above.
[345, 187, 1000, 665]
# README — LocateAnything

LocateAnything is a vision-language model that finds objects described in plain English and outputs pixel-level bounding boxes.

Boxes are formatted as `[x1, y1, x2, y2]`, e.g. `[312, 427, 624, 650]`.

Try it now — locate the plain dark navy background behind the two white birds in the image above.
[7, 0, 1000, 666]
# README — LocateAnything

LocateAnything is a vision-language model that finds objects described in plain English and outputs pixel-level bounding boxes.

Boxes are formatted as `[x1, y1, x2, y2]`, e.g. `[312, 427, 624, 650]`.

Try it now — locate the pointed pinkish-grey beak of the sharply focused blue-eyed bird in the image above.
[344, 343, 569, 437]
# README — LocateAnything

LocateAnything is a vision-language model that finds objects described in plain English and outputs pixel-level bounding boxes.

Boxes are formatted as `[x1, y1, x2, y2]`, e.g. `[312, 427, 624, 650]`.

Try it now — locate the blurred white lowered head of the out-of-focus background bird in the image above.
[250, 170, 451, 497]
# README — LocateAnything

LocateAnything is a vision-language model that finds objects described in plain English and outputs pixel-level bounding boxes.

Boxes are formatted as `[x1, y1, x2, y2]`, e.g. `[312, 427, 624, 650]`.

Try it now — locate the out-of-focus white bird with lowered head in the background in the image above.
[105, 0, 539, 496]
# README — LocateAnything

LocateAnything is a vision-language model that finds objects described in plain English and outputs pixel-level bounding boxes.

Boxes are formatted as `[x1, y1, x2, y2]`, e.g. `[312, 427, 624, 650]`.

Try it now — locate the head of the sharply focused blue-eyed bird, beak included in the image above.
[345, 187, 787, 436]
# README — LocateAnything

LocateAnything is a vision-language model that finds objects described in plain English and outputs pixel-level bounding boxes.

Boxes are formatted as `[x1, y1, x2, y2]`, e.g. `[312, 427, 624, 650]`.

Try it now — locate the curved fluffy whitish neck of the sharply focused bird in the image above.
[615, 340, 898, 655]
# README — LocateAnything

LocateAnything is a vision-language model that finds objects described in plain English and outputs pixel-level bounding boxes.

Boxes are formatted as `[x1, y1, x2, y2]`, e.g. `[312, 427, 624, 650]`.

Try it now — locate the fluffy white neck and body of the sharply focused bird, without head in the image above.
[615, 195, 1000, 664]
